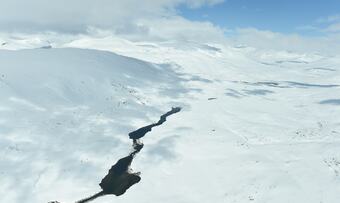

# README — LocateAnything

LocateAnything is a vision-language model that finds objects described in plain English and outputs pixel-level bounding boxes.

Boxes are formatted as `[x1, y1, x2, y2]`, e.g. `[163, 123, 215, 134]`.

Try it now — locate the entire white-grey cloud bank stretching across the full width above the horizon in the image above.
[0, 0, 340, 53]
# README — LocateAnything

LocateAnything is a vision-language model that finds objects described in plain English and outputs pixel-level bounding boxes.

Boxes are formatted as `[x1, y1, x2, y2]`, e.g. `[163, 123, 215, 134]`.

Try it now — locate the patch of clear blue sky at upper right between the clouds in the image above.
[179, 0, 340, 34]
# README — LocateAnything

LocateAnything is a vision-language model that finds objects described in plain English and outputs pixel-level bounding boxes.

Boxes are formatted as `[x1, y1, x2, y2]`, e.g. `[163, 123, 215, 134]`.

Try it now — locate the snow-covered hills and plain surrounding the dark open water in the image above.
[0, 37, 340, 203]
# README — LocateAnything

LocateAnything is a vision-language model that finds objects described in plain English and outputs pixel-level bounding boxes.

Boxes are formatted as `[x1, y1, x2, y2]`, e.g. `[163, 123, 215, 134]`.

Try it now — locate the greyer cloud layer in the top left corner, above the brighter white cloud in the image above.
[0, 0, 223, 32]
